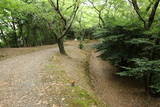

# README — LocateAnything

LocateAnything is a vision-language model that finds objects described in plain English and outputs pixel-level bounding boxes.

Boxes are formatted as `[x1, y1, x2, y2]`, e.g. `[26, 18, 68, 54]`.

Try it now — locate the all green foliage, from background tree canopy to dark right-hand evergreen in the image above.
[0, 0, 160, 93]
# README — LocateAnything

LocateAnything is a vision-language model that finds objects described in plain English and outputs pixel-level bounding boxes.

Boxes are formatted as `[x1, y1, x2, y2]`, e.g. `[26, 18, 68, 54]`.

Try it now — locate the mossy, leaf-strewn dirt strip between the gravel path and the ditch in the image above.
[41, 45, 105, 107]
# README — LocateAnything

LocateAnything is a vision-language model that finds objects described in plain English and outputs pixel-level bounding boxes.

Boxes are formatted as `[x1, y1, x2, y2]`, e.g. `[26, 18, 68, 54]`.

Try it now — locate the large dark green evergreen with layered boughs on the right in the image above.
[94, 4, 160, 94]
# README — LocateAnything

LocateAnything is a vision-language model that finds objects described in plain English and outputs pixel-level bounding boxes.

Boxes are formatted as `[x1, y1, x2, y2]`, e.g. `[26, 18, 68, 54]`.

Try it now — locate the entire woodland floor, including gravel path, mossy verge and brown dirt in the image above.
[0, 41, 160, 107]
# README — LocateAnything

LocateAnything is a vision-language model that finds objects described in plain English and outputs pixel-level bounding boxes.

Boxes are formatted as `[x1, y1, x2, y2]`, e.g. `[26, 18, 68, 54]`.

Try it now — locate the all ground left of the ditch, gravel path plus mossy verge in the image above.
[0, 41, 103, 107]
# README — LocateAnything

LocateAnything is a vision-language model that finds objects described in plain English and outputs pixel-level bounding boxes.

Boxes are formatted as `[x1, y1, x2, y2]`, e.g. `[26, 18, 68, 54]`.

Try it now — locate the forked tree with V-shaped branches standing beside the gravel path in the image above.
[48, 0, 80, 55]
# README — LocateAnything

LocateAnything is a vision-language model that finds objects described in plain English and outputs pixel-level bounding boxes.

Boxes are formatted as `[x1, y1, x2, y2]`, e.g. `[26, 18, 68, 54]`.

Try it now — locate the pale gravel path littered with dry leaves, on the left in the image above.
[0, 48, 55, 107]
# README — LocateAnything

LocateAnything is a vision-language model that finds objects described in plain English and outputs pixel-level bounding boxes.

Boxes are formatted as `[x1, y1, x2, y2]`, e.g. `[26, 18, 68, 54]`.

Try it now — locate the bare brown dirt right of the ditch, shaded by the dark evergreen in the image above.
[90, 52, 160, 107]
